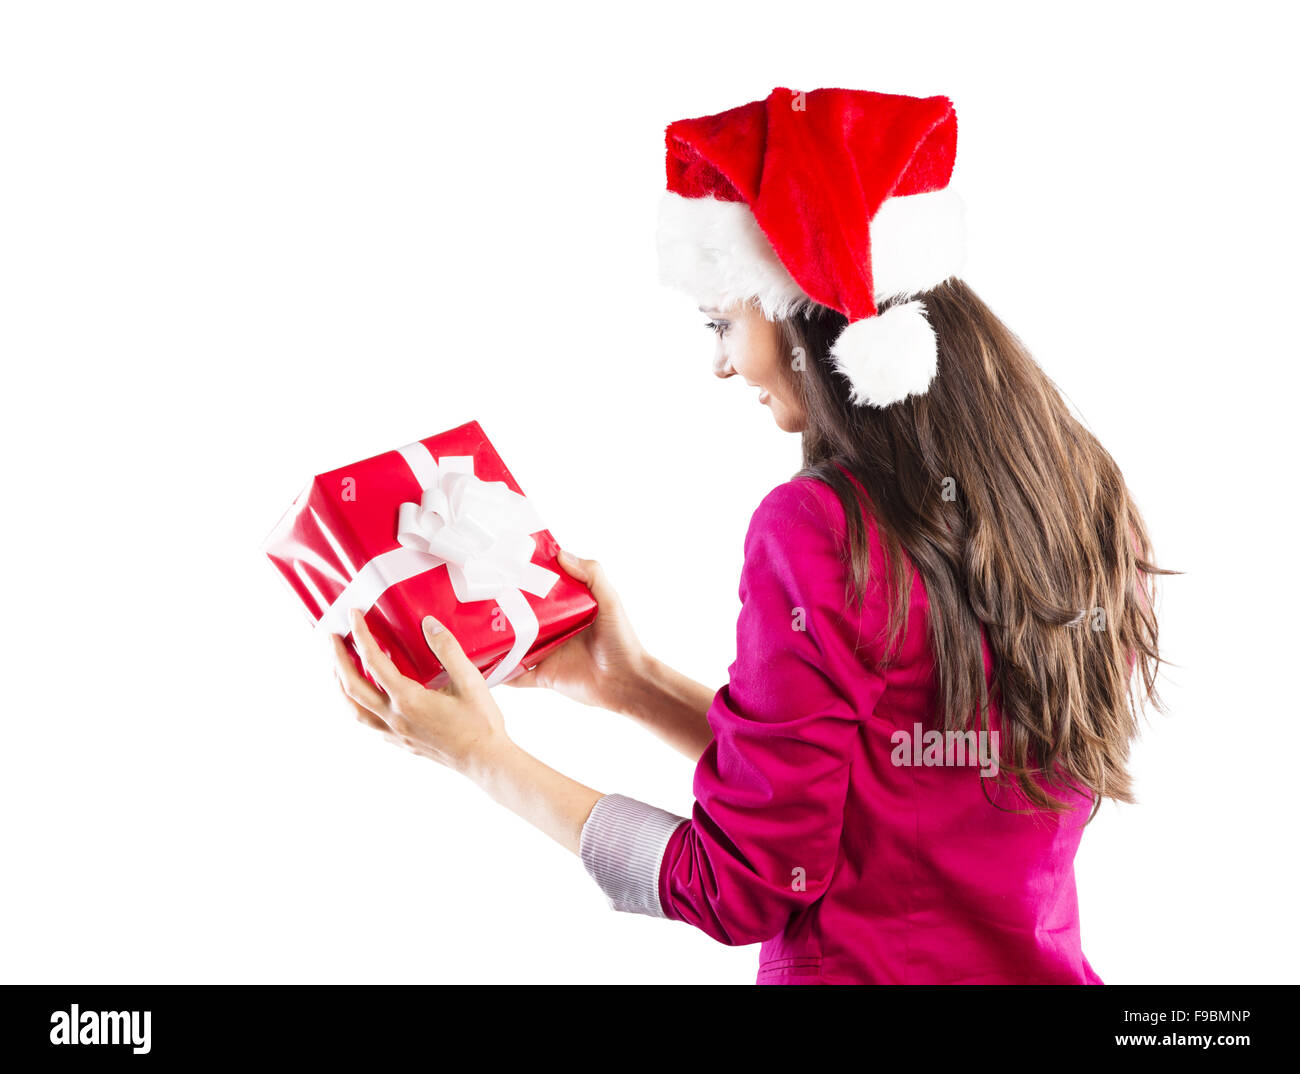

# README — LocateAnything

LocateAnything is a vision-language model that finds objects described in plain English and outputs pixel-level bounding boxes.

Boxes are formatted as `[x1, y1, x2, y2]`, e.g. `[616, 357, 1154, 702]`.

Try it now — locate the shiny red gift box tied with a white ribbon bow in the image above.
[264, 421, 597, 687]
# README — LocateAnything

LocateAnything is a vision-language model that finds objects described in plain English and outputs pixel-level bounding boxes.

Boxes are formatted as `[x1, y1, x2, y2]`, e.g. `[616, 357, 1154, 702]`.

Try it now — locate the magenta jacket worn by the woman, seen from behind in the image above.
[644, 478, 1101, 984]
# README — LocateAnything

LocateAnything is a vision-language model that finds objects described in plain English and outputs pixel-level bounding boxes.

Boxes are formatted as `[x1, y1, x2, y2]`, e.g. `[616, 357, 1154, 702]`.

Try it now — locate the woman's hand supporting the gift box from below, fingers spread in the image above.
[333, 611, 512, 775]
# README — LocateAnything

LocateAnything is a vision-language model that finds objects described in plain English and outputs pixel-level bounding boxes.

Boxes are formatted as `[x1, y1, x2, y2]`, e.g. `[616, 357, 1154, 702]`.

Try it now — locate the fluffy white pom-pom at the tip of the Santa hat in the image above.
[831, 302, 939, 407]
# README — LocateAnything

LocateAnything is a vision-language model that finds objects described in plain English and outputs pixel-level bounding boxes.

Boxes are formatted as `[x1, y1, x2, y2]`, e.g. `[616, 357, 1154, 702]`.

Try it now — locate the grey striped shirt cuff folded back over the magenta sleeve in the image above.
[579, 794, 686, 918]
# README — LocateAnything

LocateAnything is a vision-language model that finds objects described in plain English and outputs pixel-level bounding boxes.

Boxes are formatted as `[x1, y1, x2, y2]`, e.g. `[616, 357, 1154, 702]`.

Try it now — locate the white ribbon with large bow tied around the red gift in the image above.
[316, 441, 559, 687]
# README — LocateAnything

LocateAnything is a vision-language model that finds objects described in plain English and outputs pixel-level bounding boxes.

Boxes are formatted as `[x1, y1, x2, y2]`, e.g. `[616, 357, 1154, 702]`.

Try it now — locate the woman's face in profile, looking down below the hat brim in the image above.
[699, 303, 805, 433]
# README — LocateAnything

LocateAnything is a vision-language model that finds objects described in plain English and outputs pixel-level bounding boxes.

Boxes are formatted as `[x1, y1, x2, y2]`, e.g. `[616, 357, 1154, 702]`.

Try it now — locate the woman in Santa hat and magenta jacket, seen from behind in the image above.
[334, 90, 1158, 983]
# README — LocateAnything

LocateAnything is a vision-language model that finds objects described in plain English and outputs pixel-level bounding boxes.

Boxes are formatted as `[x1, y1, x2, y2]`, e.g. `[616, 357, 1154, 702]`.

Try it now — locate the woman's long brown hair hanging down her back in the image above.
[781, 278, 1174, 819]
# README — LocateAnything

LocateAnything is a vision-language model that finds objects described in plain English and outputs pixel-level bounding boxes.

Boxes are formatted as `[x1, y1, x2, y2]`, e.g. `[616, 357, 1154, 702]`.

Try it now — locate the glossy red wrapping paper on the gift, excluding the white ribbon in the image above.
[264, 421, 597, 687]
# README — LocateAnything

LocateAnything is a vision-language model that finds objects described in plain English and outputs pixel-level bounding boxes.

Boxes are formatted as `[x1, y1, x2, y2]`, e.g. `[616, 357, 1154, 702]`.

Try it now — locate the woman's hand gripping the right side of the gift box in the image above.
[508, 551, 651, 711]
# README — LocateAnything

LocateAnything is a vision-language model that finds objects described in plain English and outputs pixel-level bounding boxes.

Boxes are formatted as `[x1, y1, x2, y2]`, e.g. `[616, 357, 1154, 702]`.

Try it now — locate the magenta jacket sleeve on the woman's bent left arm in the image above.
[658, 480, 883, 944]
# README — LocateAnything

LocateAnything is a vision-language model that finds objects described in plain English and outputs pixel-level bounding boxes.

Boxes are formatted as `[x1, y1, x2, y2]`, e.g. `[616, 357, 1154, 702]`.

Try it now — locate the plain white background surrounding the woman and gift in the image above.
[0, 0, 1300, 983]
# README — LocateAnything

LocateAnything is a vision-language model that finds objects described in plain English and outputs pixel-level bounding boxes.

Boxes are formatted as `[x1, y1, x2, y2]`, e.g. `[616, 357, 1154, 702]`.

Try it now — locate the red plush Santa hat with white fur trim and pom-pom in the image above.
[659, 88, 965, 407]
